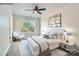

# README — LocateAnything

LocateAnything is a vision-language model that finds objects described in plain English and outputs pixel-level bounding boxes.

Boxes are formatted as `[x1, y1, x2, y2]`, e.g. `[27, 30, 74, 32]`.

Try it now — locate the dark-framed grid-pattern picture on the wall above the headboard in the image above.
[48, 13, 61, 28]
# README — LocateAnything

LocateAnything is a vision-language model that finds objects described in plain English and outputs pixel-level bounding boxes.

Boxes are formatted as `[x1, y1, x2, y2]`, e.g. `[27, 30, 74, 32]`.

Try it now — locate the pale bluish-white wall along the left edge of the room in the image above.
[0, 6, 9, 56]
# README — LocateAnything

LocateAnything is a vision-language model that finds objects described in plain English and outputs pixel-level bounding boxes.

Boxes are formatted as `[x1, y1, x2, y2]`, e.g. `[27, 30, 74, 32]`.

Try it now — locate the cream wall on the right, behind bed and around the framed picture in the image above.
[41, 4, 79, 45]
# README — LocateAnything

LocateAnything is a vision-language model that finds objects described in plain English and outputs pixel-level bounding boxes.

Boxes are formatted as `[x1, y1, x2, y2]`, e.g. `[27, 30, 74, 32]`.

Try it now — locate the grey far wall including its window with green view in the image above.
[13, 15, 40, 35]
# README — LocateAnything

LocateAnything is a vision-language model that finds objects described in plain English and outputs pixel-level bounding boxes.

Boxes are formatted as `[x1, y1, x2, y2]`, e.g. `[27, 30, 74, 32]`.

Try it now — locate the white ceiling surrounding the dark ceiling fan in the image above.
[0, 3, 69, 17]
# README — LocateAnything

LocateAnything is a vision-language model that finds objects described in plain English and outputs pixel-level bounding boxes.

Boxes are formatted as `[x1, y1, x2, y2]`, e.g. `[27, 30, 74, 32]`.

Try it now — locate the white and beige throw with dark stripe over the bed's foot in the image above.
[27, 36, 48, 56]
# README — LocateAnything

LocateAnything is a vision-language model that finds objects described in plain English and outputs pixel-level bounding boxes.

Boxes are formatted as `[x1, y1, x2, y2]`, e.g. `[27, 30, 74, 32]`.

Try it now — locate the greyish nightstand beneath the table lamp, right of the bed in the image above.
[60, 41, 77, 54]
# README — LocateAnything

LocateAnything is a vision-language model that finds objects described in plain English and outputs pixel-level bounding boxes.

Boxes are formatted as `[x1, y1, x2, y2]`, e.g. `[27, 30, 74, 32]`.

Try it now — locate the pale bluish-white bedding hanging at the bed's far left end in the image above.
[19, 40, 32, 56]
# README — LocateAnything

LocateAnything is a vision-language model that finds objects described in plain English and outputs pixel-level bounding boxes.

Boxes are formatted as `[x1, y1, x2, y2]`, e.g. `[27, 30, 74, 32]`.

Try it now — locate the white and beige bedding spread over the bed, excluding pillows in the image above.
[21, 36, 61, 56]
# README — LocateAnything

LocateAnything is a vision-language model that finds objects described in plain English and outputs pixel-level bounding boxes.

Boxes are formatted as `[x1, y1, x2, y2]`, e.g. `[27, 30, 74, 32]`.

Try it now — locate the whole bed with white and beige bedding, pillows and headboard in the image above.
[21, 28, 64, 56]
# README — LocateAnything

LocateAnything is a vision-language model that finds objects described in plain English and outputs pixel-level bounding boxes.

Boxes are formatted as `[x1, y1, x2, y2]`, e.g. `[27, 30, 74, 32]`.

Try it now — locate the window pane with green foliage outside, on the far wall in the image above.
[20, 17, 36, 32]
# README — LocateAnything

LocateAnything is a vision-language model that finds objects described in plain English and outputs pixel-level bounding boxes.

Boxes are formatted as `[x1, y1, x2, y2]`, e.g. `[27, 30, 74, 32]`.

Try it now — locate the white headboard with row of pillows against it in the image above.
[45, 28, 64, 40]
